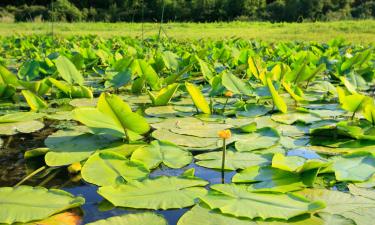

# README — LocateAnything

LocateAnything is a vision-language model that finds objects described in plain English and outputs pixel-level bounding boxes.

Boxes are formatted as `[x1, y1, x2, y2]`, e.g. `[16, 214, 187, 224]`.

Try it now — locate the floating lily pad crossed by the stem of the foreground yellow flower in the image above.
[195, 151, 270, 170]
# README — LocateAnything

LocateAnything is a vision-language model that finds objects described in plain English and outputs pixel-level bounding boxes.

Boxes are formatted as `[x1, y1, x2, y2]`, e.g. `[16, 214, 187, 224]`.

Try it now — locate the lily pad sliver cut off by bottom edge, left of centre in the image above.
[87, 212, 168, 225]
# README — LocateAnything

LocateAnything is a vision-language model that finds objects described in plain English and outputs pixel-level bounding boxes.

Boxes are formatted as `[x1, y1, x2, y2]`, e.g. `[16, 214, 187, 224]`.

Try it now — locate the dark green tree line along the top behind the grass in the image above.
[0, 0, 375, 22]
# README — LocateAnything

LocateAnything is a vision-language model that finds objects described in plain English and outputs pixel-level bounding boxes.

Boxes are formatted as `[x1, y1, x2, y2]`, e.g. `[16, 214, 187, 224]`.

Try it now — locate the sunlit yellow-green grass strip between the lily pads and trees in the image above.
[0, 20, 375, 44]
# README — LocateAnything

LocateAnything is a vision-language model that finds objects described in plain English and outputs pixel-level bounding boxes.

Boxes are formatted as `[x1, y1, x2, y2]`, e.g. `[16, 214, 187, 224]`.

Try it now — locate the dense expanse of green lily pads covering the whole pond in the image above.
[0, 36, 375, 225]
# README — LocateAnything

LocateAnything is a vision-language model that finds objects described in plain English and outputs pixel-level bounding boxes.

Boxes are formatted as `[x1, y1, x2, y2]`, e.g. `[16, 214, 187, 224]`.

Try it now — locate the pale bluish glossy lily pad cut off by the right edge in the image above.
[333, 152, 375, 182]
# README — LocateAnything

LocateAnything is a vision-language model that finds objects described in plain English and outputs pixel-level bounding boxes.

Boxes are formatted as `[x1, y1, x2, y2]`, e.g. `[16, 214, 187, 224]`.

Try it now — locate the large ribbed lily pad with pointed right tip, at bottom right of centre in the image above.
[201, 184, 324, 219]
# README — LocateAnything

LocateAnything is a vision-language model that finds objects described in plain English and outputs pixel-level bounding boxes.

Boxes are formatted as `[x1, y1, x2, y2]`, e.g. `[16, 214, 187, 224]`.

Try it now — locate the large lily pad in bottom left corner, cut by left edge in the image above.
[0, 186, 85, 224]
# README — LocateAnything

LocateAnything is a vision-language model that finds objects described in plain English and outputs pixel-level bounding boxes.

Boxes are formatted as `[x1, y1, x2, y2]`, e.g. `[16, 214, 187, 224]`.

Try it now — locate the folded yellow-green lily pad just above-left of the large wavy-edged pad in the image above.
[81, 150, 149, 186]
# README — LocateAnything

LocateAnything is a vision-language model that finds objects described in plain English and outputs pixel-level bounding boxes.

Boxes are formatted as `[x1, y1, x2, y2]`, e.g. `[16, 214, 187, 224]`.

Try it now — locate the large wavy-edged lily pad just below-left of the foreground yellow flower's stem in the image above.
[98, 176, 208, 210]
